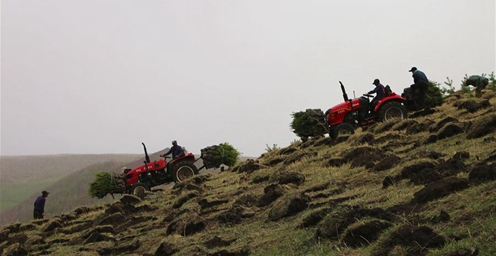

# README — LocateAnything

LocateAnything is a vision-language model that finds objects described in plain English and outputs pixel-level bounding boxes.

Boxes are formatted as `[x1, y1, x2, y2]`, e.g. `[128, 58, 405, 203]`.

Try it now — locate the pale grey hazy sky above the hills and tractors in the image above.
[0, 0, 496, 156]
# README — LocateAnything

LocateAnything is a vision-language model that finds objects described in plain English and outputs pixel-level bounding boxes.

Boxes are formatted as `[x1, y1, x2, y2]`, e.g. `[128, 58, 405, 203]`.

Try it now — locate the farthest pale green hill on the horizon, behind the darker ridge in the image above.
[0, 154, 141, 214]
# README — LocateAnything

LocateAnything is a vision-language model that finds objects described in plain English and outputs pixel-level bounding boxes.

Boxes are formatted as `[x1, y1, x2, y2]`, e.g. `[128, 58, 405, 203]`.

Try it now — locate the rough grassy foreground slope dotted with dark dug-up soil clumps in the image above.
[0, 92, 496, 256]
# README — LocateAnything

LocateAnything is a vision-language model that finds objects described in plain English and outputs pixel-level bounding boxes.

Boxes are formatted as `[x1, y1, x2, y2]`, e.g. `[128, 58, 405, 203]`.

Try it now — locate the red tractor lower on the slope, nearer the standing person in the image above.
[112, 143, 206, 194]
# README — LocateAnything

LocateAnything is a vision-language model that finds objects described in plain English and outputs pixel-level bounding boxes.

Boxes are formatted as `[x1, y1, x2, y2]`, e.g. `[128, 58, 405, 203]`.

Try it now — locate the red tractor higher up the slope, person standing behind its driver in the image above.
[325, 81, 407, 139]
